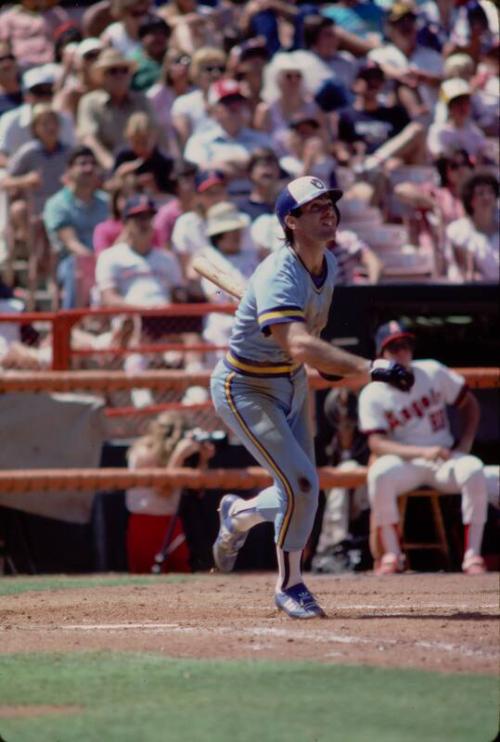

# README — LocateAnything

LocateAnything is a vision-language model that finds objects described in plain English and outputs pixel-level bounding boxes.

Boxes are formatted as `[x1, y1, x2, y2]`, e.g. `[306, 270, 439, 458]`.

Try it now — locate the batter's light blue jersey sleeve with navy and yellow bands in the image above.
[254, 268, 306, 333]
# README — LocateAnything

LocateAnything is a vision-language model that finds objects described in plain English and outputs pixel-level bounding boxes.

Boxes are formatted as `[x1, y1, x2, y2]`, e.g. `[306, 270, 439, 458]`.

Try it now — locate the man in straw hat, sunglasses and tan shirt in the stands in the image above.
[77, 49, 154, 170]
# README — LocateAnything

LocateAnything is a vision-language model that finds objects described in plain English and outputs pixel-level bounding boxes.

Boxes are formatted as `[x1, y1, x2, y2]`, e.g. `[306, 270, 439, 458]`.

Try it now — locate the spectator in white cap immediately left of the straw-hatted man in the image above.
[54, 37, 104, 121]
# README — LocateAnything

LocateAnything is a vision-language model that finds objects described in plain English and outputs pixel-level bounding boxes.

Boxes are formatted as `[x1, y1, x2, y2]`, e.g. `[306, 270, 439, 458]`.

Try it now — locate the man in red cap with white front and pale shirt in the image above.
[184, 79, 271, 195]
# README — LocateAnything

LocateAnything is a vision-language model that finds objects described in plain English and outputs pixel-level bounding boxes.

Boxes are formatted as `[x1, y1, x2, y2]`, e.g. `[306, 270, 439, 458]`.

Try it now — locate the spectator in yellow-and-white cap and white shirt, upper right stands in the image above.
[427, 77, 488, 162]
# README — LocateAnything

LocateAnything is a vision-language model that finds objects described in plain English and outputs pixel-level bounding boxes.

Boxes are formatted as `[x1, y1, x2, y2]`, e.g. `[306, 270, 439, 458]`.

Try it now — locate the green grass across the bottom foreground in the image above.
[0, 653, 498, 742]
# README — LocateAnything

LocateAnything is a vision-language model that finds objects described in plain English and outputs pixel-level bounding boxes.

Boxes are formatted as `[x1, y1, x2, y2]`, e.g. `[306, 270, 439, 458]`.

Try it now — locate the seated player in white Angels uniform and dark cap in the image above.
[359, 322, 487, 575]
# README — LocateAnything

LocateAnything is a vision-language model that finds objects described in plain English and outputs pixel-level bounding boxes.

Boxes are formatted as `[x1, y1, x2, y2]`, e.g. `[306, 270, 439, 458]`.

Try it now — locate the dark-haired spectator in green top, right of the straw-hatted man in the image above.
[131, 15, 171, 91]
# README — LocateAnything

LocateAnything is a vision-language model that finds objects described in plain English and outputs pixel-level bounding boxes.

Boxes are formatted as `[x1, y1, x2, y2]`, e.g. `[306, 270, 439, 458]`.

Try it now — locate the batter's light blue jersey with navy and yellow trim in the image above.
[225, 246, 337, 376]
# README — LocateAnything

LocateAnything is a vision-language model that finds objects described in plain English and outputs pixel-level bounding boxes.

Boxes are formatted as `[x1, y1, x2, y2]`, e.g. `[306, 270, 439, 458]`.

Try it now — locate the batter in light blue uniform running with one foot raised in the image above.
[211, 176, 411, 619]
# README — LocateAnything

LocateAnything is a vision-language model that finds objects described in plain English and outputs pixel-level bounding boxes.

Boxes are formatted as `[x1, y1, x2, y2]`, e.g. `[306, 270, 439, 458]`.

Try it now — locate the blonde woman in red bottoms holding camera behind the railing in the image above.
[126, 412, 215, 573]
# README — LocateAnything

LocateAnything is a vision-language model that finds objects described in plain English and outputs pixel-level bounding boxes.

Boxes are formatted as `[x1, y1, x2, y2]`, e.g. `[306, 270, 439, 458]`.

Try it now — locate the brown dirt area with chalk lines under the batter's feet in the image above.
[0, 573, 500, 674]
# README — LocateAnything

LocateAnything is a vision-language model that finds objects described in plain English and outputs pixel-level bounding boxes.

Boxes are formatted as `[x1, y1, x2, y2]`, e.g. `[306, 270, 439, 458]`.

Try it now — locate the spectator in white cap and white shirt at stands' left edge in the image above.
[0, 64, 75, 167]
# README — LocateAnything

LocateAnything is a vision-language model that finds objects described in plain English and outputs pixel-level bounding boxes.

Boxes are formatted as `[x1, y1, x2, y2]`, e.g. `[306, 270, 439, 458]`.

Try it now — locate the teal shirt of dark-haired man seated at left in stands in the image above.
[43, 187, 109, 255]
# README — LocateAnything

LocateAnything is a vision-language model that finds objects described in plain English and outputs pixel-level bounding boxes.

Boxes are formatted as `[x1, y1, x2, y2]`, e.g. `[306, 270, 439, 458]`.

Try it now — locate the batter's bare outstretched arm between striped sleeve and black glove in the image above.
[270, 322, 371, 384]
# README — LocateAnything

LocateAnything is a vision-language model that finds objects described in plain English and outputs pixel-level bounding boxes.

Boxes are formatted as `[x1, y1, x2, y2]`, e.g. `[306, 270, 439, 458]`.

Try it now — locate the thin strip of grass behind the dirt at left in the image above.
[0, 574, 190, 600]
